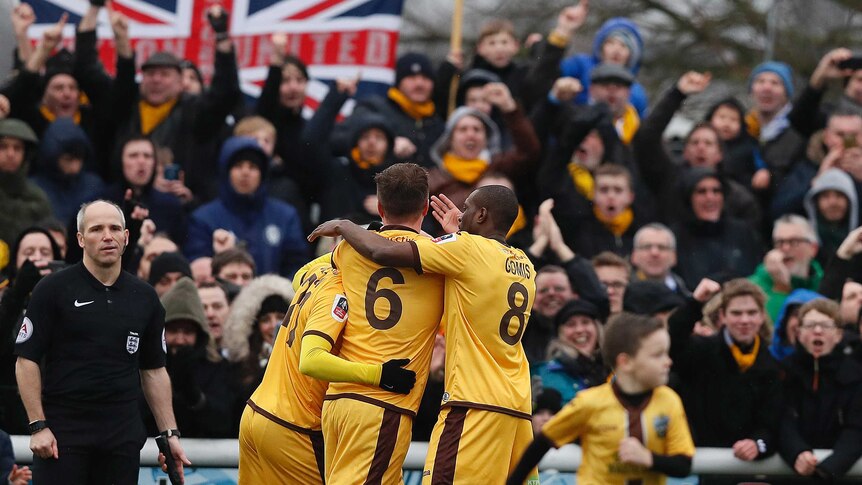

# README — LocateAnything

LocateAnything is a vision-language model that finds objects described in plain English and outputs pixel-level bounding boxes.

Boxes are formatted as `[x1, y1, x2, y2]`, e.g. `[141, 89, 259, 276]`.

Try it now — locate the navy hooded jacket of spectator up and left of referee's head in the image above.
[32, 118, 105, 223]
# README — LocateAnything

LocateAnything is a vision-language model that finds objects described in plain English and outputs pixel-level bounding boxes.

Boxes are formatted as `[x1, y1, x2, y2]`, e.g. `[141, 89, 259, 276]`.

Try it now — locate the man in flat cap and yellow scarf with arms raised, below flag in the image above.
[76, 5, 241, 195]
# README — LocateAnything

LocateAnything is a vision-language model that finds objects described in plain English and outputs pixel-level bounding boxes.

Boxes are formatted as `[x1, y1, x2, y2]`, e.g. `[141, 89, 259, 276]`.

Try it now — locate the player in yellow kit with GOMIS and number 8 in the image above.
[311, 185, 538, 485]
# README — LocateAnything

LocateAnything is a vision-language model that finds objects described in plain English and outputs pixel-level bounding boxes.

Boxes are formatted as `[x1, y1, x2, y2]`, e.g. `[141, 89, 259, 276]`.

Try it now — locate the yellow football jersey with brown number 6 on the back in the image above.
[314, 226, 443, 415]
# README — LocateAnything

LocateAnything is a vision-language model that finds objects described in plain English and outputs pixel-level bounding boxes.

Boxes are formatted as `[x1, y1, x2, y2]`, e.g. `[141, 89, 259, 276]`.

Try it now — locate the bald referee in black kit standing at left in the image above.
[15, 200, 191, 485]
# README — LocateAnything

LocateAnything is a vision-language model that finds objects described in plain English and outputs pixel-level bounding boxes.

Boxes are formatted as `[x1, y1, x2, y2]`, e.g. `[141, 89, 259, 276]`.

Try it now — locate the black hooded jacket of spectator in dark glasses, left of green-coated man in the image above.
[671, 168, 763, 288]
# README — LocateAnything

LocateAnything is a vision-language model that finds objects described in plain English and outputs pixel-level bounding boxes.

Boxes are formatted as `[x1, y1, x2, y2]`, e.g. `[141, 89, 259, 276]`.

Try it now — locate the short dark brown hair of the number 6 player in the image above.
[374, 163, 428, 217]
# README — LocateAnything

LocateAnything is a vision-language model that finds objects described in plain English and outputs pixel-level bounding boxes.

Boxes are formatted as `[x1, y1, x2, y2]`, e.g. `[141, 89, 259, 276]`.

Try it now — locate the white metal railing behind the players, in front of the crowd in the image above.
[12, 436, 862, 478]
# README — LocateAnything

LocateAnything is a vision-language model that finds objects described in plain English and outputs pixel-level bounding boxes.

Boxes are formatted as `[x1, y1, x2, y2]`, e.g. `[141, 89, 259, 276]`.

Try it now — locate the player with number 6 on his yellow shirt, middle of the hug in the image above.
[300, 163, 443, 485]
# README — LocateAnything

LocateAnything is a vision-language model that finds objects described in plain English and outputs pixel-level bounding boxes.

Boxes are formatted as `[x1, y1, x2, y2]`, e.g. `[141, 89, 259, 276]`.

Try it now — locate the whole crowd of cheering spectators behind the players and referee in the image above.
[0, 2, 862, 483]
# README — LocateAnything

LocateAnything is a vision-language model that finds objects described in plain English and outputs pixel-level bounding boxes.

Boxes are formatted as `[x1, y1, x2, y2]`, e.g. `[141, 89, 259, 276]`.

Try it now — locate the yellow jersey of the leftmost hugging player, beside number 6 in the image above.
[249, 267, 347, 430]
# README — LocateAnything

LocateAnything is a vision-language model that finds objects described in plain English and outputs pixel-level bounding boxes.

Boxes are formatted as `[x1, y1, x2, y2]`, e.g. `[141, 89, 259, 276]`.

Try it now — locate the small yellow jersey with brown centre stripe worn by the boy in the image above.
[542, 383, 694, 485]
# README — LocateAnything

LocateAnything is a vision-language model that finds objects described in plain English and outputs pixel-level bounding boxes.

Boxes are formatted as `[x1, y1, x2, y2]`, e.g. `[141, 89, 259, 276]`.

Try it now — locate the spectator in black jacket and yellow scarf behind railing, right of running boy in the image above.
[669, 279, 781, 485]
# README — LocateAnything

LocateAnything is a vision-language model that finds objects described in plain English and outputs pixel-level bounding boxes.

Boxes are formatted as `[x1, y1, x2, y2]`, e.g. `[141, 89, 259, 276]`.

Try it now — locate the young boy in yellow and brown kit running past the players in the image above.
[506, 313, 694, 485]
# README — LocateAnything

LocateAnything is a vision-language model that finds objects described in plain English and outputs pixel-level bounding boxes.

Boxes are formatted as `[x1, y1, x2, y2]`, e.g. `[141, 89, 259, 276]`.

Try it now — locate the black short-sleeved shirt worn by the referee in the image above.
[15, 262, 165, 405]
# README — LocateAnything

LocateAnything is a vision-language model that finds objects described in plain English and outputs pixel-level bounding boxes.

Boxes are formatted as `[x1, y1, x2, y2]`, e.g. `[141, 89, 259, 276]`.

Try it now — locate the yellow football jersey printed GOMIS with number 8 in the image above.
[413, 232, 536, 419]
